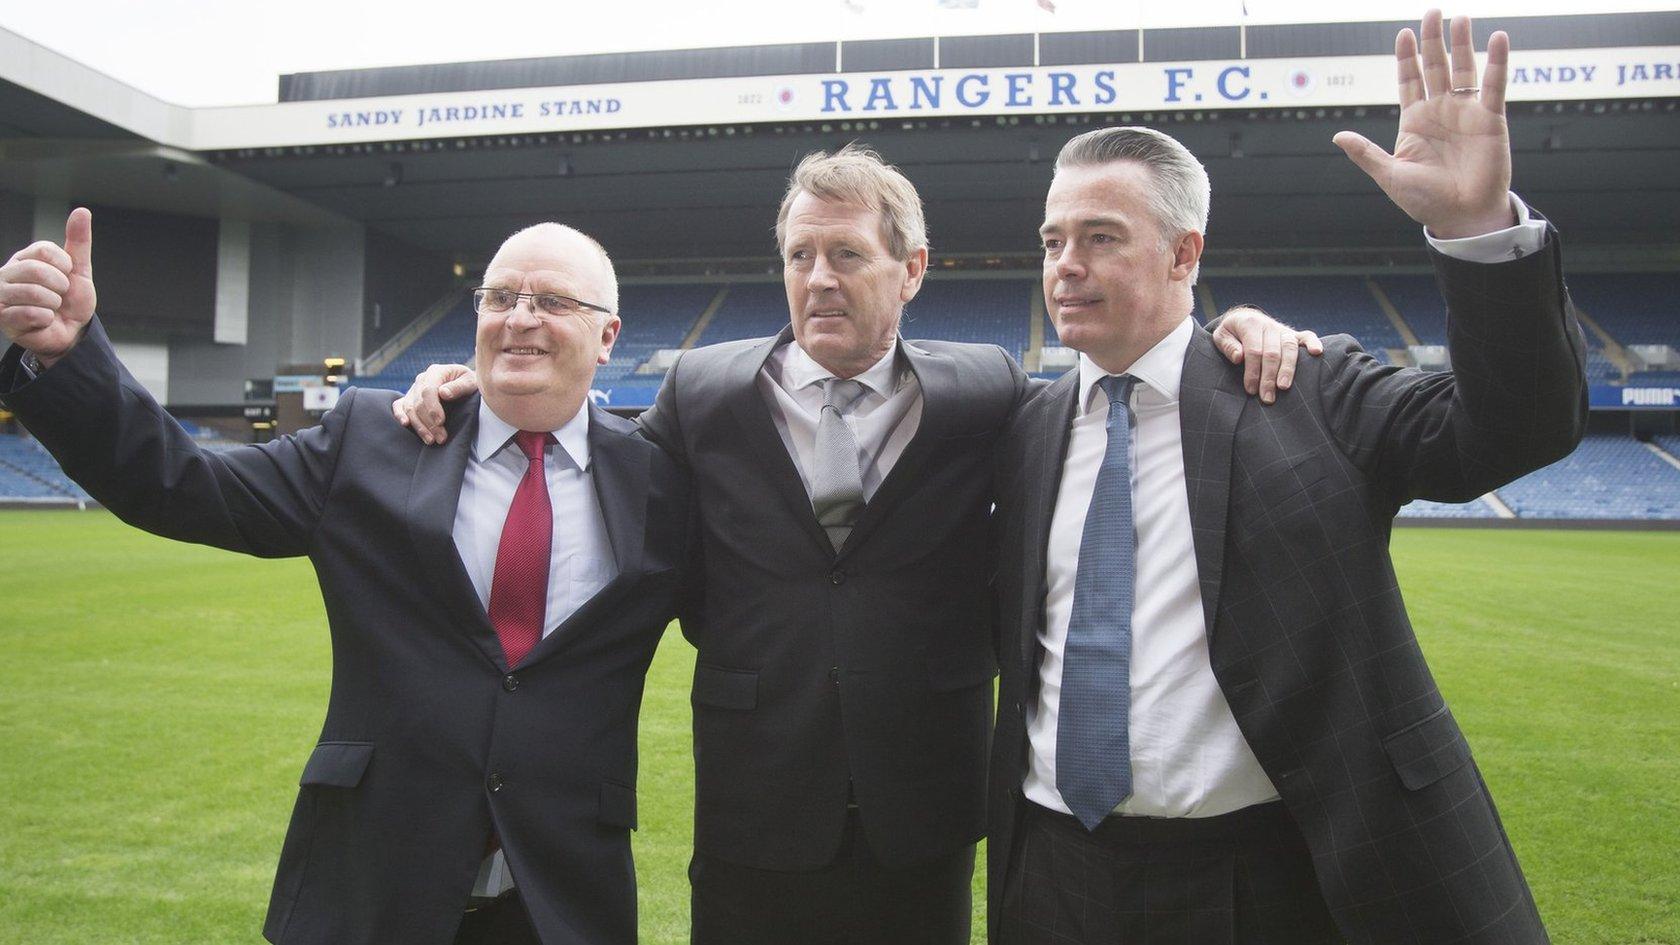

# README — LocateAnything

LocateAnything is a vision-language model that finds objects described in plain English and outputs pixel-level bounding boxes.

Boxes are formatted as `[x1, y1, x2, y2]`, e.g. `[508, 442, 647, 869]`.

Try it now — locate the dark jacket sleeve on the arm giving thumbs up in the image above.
[0, 319, 356, 558]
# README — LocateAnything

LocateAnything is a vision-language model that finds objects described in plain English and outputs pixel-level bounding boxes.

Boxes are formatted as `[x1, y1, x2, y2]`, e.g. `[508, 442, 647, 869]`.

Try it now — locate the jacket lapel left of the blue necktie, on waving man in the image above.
[1018, 368, 1079, 668]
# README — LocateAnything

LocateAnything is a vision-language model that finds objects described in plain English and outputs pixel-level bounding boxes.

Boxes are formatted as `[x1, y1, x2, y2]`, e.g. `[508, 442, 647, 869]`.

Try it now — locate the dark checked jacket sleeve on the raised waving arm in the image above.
[1317, 223, 1588, 506]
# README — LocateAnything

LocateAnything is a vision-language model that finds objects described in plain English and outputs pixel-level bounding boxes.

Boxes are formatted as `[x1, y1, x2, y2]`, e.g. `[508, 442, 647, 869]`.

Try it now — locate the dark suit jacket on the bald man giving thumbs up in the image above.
[0, 323, 687, 945]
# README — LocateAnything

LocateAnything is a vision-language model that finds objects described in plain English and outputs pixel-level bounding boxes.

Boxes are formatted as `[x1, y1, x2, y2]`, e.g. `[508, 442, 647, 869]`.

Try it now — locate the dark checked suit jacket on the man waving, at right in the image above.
[990, 239, 1586, 945]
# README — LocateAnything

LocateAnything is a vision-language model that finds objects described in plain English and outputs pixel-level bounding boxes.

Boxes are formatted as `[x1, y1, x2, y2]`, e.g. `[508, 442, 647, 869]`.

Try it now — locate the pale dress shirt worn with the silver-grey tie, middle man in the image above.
[758, 340, 922, 501]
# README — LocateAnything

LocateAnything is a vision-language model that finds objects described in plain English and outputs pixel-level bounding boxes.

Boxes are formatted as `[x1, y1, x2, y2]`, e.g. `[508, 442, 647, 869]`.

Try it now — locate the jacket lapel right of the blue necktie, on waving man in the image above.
[1178, 326, 1248, 639]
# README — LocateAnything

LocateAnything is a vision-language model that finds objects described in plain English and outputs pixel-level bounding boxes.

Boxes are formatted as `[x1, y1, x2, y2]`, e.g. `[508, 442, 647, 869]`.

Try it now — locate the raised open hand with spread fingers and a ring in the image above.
[1336, 10, 1517, 239]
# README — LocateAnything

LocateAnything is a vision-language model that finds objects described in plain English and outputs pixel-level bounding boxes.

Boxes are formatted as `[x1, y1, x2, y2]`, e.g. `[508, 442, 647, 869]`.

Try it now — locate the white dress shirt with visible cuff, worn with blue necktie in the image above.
[1023, 207, 1546, 817]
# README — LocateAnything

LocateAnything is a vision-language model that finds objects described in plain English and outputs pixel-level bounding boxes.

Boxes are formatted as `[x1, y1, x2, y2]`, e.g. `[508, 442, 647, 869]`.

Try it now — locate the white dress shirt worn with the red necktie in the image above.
[454, 400, 618, 896]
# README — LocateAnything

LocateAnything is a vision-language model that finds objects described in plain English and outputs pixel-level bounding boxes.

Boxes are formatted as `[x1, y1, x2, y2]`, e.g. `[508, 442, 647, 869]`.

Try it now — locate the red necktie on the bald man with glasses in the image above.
[491, 430, 554, 669]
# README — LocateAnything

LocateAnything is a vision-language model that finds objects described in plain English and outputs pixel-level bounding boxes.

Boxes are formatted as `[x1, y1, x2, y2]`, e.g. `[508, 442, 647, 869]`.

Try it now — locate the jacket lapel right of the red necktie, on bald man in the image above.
[519, 404, 652, 669]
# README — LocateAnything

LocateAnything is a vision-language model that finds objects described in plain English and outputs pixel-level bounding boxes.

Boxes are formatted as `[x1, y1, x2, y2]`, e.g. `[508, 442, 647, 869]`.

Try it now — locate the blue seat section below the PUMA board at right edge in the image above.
[1499, 434, 1680, 520]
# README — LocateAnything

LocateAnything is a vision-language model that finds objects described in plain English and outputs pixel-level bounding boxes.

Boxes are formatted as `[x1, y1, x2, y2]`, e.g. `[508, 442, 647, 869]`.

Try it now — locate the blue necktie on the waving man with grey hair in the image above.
[1055, 377, 1137, 831]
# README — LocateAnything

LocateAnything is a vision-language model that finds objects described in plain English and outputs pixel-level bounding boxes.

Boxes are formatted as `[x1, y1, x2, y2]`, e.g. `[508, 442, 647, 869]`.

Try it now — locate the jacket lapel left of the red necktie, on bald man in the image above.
[408, 395, 507, 671]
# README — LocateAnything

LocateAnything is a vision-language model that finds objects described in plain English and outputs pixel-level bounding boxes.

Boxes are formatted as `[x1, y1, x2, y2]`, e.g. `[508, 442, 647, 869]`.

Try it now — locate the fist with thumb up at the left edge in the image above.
[0, 207, 96, 367]
